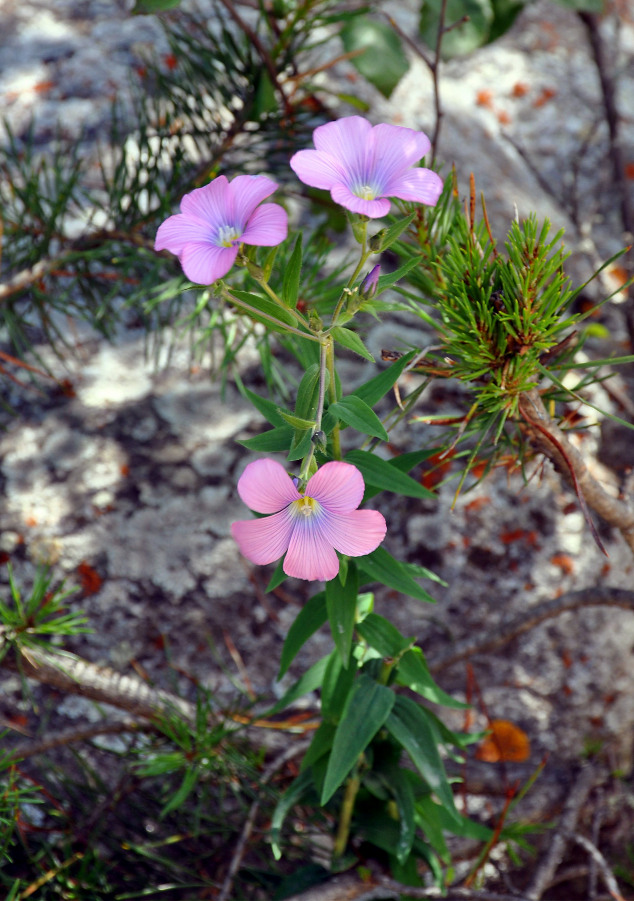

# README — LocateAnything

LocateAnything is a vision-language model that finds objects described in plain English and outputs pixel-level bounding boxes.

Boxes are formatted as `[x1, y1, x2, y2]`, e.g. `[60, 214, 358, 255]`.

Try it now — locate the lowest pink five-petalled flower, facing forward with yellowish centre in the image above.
[231, 459, 387, 582]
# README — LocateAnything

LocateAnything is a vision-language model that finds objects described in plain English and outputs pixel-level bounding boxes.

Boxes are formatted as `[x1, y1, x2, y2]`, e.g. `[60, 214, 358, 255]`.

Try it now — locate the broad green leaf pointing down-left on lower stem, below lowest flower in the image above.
[321, 674, 396, 806]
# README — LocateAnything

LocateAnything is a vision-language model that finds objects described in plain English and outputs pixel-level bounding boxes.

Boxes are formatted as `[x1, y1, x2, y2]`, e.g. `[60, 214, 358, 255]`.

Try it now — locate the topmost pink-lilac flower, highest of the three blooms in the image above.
[291, 116, 442, 219]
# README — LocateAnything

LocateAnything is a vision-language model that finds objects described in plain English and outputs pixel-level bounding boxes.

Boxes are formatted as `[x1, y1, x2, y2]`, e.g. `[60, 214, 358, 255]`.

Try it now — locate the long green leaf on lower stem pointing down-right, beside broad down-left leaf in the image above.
[382, 695, 459, 821]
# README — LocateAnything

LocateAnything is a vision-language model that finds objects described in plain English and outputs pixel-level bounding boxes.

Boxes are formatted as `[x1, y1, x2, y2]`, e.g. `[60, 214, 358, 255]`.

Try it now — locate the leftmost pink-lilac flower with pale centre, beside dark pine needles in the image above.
[154, 175, 288, 285]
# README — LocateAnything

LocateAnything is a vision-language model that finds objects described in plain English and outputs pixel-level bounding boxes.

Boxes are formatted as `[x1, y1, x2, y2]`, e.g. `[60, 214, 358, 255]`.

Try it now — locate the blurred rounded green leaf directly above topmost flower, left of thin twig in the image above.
[340, 16, 409, 97]
